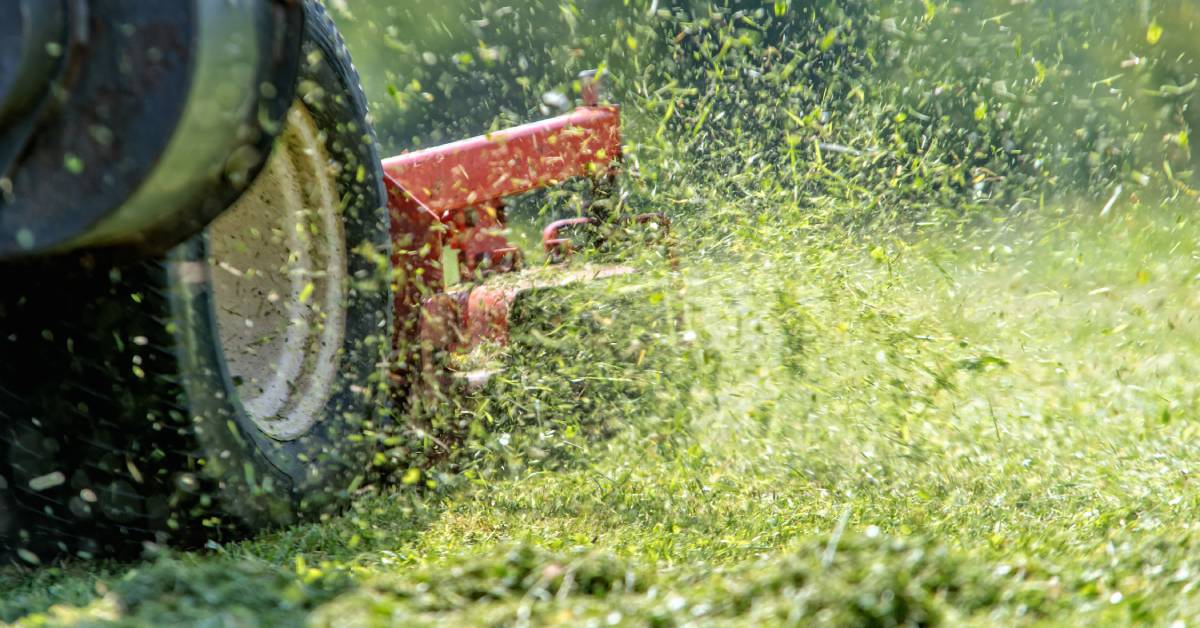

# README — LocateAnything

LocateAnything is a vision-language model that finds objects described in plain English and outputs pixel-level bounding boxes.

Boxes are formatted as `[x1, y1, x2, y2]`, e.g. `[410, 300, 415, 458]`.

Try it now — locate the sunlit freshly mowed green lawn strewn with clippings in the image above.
[0, 201, 1200, 626]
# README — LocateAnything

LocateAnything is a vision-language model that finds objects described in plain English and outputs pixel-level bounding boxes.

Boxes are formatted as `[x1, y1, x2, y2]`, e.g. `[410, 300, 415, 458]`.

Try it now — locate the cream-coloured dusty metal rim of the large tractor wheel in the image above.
[209, 101, 347, 441]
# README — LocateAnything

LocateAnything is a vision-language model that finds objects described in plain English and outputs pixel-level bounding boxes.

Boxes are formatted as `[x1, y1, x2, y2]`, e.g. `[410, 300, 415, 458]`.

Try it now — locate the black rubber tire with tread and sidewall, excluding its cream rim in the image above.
[0, 0, 391, 564]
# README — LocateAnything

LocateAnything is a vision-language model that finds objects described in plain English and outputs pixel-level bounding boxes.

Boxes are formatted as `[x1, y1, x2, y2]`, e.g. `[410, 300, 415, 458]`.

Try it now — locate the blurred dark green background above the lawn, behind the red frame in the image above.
[332, 0, 1200, 221]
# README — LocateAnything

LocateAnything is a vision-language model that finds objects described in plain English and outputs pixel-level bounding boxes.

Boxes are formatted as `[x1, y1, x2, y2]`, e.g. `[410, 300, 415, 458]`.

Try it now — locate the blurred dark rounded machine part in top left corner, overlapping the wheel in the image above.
[0, 0, 305, 261]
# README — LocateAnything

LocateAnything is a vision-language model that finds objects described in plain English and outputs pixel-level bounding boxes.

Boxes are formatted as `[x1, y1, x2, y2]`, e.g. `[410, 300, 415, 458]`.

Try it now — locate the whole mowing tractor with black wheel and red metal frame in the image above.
[0, 0, 667, 564]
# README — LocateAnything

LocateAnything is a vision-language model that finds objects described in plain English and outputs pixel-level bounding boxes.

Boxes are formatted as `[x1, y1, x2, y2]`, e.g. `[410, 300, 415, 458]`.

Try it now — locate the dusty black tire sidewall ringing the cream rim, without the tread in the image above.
[168, 2, 390, 527]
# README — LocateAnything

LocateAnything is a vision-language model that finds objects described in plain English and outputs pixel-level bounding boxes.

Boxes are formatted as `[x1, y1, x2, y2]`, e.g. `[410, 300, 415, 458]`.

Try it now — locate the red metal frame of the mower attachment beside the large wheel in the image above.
[383, 98, 622, 377]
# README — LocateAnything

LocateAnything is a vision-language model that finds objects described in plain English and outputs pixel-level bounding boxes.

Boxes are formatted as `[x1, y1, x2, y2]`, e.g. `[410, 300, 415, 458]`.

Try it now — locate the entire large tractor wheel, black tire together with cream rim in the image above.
[0, 0, 391, 564]
